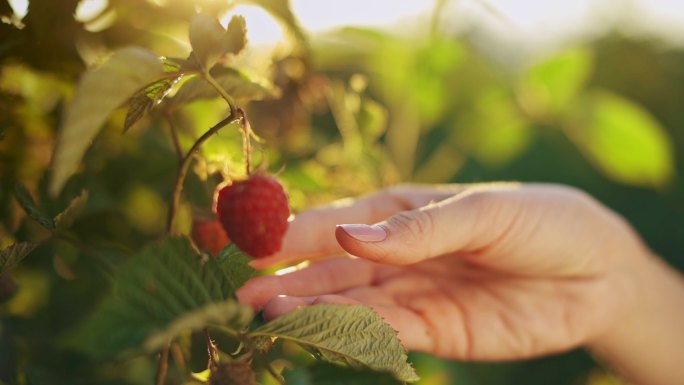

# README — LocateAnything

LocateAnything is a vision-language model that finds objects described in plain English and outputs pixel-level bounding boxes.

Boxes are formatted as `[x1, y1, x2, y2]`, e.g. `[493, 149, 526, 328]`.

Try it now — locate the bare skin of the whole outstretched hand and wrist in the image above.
[238, 184, 684, 385]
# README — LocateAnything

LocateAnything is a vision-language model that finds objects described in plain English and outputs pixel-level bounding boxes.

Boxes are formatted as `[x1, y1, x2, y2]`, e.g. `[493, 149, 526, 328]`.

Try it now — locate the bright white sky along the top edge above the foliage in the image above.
[9, 0, 684, 50]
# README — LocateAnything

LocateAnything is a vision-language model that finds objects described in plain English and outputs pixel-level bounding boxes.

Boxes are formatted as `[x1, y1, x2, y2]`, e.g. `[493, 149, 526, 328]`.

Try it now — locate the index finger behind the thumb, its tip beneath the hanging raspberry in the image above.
[251, 185, 464, 269]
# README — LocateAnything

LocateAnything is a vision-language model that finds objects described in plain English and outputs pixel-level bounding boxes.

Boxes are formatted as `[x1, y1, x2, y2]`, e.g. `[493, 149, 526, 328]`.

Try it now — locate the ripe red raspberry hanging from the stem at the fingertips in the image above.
[216, 174, 290, 258]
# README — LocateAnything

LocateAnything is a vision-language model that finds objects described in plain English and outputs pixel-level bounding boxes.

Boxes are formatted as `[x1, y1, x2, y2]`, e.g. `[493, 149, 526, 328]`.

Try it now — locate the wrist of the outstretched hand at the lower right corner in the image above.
[587, 250, 684, 385]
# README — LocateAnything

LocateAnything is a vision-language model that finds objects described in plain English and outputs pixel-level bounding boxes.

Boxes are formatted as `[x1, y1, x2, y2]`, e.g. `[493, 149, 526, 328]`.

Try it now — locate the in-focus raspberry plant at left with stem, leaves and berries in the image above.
[0, 5, 417, 385]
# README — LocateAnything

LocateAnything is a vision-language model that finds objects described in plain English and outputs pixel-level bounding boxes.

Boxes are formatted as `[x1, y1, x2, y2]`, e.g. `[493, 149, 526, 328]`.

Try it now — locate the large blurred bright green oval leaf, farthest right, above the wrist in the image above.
[566, 91, 674, 187]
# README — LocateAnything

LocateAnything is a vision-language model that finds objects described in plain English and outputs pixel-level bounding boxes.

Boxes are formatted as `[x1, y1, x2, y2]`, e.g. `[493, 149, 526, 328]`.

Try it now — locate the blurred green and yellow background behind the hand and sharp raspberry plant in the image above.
[0, 0, 684, 385]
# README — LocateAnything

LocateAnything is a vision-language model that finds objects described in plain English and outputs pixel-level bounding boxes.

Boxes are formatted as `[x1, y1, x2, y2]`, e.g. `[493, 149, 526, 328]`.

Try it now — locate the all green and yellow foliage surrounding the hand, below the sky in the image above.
[0, 0, 684, 385]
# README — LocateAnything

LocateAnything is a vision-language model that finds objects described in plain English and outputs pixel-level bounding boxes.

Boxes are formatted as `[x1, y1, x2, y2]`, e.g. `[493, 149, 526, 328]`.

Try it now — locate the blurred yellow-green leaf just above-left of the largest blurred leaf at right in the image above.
[521, 48, 593, 113]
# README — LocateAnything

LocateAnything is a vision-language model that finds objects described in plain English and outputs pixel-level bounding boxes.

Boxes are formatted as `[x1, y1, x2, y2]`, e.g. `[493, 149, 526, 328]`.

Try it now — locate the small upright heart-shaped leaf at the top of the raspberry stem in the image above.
[189, 13, 247, 70]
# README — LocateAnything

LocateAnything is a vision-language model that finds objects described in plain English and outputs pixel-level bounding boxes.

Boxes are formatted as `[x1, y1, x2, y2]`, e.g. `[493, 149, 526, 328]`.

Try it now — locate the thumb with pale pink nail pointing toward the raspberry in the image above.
[335, 196, 479, 265]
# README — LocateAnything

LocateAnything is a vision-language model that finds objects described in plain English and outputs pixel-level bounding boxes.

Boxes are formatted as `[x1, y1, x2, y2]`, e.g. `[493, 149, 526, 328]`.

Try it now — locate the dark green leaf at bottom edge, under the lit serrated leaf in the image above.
[283, 361, 403, 385]
